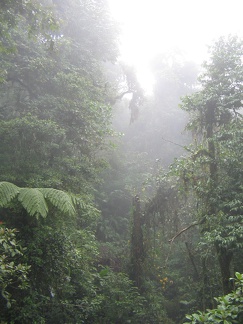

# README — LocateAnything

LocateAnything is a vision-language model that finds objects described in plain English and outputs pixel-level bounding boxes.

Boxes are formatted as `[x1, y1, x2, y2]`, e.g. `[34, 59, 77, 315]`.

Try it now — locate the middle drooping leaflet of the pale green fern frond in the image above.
[18, 188, 48, 218]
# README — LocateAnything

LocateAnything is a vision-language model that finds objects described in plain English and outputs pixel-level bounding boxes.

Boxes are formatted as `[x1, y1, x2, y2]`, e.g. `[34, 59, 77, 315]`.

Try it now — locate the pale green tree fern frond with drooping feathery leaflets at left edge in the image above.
[0, 182, 75, 218]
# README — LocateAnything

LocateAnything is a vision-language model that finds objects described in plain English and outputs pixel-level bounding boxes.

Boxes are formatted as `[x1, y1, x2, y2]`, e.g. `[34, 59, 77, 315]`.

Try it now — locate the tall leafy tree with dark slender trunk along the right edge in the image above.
[178, 37, 243, 293]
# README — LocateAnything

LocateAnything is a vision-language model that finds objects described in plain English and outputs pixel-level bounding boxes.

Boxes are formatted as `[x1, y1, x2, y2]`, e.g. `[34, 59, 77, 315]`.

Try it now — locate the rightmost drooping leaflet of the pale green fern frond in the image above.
[39, 188, 76, 216]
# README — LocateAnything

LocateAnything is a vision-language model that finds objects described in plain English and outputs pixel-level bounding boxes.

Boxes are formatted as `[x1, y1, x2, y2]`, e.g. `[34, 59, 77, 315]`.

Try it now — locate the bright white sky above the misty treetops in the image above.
[109, 0, 243, 91]
